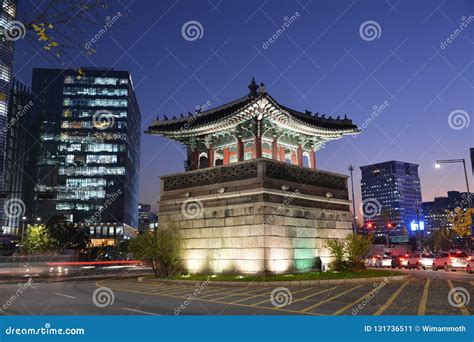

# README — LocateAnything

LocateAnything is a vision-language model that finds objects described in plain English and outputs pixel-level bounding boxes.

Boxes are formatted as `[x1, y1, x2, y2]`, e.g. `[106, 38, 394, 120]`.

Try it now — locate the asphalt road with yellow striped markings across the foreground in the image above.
[0, 271, 474, 315]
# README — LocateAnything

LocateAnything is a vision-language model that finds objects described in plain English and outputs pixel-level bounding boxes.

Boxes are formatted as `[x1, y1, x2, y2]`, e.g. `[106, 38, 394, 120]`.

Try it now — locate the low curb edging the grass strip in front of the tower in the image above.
[137, 275, 410, 287]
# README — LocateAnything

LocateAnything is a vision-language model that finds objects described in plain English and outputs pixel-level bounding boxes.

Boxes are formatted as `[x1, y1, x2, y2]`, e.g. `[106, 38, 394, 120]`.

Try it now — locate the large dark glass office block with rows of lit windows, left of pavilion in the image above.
[27, 68, 140, 244]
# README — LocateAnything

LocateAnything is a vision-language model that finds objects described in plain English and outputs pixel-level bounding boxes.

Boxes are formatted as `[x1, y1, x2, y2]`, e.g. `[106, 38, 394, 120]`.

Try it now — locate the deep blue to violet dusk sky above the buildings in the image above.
[14, 0, 474, 214]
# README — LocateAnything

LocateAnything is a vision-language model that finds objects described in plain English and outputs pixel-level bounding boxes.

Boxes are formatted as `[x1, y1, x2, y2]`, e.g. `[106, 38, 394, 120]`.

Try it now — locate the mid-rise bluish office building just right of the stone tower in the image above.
[360, 161, 422, 232]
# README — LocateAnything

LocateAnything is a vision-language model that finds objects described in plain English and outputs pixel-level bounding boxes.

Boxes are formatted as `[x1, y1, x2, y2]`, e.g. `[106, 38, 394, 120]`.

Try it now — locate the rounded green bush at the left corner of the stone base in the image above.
[128, 225, 182, 277]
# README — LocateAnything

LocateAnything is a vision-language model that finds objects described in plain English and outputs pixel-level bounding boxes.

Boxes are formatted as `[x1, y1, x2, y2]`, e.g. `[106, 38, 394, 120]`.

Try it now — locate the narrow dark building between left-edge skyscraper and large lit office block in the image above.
[2, 80, 34, 236]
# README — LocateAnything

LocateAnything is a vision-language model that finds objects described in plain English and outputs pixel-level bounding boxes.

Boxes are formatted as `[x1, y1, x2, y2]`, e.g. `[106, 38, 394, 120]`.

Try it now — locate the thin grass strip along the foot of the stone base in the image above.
[168, 270, 403, 282]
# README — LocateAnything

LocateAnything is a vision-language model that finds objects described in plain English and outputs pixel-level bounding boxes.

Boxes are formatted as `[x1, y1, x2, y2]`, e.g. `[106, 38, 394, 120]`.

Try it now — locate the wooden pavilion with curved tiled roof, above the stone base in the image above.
[146, 79, 359, 170]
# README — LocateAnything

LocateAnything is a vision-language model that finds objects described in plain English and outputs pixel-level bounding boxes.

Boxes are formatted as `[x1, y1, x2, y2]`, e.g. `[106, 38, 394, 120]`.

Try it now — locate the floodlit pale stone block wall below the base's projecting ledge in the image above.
[159, 202, 352, 274]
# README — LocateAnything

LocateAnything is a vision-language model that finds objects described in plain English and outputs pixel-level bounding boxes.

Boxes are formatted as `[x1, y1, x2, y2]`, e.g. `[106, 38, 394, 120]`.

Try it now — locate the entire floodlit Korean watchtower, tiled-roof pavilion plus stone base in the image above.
[146, 79, 359, 274]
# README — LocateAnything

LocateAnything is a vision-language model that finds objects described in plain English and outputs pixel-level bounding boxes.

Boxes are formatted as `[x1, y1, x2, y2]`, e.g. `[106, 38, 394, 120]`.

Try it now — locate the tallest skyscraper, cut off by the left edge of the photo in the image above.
[0, 0, 17, 228]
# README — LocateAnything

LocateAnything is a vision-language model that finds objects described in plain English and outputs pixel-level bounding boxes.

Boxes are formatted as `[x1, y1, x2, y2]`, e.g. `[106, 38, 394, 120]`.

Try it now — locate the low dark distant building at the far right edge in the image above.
[422, 191, 474, 231]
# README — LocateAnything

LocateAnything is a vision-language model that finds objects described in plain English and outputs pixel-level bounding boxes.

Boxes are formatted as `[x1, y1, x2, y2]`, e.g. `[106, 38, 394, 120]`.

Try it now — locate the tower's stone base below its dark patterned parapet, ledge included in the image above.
[159, 158, 352, 274]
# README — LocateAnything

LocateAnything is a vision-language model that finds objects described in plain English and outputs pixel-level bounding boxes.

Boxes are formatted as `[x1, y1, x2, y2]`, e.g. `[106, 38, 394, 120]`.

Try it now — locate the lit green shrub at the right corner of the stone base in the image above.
[326, 234, 372, 271]
